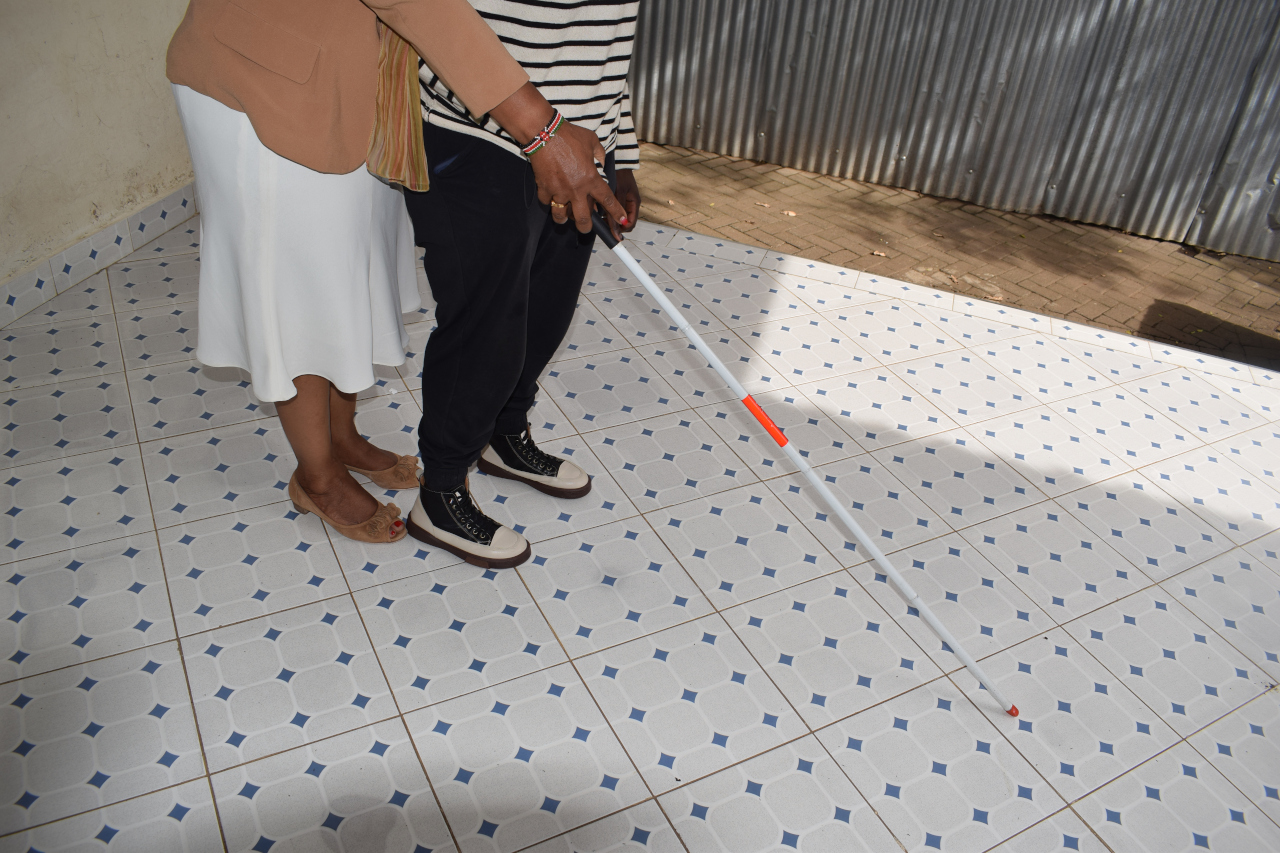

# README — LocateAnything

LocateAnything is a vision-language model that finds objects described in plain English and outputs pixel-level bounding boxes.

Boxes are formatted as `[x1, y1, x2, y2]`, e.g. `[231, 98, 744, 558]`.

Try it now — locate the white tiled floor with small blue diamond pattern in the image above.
[0, 223, 1280, 853]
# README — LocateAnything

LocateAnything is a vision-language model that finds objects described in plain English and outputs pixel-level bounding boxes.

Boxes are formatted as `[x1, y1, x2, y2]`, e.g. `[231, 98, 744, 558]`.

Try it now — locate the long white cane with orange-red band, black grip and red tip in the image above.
[591, 211, 1018, 717]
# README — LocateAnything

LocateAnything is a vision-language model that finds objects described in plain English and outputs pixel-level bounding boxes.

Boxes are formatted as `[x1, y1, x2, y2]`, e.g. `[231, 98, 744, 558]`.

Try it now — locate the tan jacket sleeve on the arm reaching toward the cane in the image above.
[361, 0, 529, 118]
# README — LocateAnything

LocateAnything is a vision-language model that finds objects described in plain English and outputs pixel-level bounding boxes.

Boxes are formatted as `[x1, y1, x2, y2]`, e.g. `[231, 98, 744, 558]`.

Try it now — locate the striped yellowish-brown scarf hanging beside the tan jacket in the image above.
[366, 20, 430, 192]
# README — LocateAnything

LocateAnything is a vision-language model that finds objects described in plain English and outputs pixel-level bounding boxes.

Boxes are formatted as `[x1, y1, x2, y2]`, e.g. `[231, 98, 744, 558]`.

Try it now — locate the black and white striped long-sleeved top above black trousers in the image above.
[419, 0, 640, 169]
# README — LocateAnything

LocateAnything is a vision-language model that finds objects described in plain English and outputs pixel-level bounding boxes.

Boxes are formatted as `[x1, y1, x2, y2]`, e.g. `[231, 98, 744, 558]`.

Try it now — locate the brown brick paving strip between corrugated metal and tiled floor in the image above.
[639, 143, 1280, 369]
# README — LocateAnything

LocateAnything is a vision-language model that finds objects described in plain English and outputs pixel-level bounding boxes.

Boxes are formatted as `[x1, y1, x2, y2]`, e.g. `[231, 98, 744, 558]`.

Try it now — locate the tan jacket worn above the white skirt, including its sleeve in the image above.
[166, 0, 529, 174]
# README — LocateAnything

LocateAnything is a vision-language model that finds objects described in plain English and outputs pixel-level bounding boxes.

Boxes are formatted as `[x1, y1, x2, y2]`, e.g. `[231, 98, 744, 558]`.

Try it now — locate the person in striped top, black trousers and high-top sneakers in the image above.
[404, 0, 640, 569]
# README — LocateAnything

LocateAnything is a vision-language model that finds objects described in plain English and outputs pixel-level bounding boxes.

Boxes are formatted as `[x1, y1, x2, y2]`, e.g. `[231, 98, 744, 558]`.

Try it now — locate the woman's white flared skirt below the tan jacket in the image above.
[173, 86, 421, 401]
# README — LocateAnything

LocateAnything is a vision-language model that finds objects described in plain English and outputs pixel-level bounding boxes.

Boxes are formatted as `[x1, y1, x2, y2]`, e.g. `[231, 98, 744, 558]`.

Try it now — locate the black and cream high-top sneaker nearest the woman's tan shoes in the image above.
[407, 483, 530, 569]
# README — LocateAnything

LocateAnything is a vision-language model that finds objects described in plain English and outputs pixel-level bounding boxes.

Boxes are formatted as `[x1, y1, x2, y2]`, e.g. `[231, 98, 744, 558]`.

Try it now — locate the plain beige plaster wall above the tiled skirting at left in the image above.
[0, 0, 191, 280]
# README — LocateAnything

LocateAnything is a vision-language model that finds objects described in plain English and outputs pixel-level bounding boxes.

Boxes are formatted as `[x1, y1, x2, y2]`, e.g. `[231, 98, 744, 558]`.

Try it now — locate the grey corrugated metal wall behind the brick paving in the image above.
[632, 0, 1280, 260]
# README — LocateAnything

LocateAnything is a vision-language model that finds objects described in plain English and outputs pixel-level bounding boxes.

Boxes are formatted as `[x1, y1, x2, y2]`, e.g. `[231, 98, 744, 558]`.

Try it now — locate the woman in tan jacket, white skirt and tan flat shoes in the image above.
[166, 0, 624, 542]
